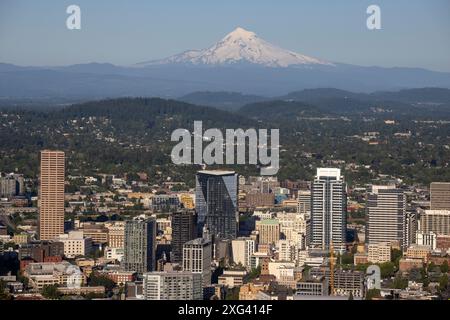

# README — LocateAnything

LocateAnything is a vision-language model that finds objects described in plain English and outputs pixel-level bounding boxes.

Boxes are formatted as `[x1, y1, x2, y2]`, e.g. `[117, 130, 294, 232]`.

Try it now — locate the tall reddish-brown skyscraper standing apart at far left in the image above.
[39, 150, 65, 240]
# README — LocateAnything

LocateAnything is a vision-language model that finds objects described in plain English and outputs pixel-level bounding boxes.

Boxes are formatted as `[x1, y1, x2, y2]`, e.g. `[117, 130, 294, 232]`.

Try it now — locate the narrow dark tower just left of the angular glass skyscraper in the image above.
[170, 211, 197, 263]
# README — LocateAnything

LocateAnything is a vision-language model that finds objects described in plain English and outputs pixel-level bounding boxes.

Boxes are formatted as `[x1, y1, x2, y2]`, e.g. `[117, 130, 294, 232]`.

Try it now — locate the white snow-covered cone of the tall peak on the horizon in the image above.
[138, 28, 333, 68]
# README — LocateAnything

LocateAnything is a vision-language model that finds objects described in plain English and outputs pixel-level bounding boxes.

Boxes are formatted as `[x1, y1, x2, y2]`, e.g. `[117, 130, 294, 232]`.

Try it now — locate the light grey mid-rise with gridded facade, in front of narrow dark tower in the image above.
[183, 238, 212, 287]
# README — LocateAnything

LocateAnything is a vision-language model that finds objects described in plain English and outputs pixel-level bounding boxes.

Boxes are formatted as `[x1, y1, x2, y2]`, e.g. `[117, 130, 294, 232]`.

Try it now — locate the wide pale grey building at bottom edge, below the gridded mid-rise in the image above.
[143, 271, 203, 300]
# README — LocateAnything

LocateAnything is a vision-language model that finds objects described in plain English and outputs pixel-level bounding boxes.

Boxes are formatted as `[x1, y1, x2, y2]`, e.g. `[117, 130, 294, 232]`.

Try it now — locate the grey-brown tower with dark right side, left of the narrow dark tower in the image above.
[122, 216, 156, 273]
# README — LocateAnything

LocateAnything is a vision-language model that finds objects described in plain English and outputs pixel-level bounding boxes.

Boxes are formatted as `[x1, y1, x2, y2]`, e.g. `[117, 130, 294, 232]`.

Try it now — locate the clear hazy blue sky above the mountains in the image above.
[0, 0, 450, 72]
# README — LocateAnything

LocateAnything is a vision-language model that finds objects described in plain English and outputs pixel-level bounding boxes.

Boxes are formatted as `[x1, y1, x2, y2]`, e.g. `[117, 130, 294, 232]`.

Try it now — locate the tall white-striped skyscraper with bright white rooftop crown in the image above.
[310, 168, 347, 251]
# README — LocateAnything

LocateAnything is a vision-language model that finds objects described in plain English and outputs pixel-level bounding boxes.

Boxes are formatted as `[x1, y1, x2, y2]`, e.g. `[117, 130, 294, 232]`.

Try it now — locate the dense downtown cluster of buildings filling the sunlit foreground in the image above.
[0, 150, 450, 301]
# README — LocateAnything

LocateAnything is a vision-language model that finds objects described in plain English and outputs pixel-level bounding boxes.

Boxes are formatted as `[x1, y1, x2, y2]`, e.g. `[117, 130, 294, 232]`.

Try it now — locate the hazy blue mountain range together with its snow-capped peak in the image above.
[0, 28, 450, 100]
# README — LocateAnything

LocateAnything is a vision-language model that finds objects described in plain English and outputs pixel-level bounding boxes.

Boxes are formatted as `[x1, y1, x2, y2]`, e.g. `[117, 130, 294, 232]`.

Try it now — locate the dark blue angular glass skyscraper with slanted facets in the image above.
[195, 170, 238, 239]
